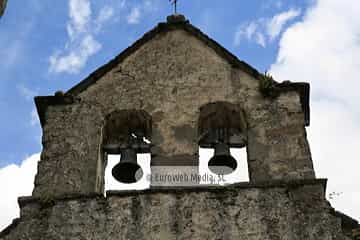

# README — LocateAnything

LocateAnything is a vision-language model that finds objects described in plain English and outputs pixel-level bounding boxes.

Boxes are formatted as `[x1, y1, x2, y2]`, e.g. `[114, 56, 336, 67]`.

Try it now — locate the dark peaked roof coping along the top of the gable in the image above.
[35, 15, 310, 125]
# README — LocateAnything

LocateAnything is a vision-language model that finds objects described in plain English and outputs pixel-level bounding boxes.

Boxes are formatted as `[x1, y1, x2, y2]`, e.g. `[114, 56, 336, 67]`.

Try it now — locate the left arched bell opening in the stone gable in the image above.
[102, 109, 151, 191]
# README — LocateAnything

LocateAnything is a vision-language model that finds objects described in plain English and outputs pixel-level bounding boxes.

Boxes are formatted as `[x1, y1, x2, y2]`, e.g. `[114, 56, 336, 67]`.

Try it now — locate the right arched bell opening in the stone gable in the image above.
[198, 102, 249, 184]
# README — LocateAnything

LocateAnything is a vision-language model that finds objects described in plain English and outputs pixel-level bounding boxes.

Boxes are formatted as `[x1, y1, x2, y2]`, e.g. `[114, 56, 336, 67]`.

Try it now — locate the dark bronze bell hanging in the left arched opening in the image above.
[112, 148, 143, 183]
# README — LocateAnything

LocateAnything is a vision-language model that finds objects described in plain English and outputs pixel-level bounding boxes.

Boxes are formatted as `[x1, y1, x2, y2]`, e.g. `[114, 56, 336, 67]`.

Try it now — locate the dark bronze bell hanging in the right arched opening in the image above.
[208, 143, 237, 175]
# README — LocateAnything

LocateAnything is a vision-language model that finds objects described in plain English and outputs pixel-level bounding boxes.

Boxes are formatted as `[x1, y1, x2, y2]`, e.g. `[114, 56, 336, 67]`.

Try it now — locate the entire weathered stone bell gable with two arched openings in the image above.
[0, 15, 358, 240]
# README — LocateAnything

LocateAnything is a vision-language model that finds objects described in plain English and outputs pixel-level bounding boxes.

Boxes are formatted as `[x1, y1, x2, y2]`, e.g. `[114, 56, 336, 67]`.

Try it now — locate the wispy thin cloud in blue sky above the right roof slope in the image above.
[234, 9, 301, 47]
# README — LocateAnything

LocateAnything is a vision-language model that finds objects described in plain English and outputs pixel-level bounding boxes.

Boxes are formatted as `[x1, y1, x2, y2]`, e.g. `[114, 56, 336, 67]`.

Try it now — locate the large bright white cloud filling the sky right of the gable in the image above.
[270, 0, 360, 219]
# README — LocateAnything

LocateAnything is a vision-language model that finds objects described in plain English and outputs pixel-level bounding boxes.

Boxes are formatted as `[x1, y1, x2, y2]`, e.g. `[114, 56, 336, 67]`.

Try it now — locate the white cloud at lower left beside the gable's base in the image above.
[0, 153, 40, 231]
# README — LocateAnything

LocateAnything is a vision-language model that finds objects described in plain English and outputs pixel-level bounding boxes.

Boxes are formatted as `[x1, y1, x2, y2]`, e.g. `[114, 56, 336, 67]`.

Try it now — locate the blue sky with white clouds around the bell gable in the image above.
[0, 0, 360, 231]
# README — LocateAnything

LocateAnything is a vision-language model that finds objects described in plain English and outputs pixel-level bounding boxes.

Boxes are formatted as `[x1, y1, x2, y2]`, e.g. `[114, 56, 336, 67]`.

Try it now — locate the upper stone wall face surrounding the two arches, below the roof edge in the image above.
[34, 29, 314, 196]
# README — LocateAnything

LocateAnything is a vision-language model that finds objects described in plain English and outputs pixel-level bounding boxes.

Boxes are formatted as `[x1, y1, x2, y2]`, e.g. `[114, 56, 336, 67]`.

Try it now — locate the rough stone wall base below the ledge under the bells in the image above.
[0, 181, 349, 240]
